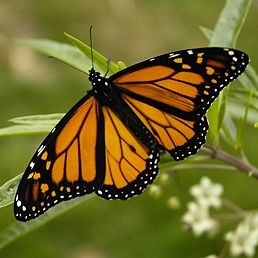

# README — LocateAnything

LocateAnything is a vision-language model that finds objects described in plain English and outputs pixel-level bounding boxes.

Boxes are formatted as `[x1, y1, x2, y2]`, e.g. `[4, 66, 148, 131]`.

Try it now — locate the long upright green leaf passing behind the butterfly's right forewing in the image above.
[207, 0, 252, 144]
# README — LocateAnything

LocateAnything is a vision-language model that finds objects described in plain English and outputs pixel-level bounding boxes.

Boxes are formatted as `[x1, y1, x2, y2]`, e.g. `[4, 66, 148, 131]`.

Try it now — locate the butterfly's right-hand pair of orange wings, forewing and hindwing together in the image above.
[110, 48, 248, 160]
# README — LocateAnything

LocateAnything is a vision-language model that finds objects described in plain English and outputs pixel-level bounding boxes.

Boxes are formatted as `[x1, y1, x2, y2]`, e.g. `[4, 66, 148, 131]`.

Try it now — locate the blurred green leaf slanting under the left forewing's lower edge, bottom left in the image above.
[0, 195, 91, 249]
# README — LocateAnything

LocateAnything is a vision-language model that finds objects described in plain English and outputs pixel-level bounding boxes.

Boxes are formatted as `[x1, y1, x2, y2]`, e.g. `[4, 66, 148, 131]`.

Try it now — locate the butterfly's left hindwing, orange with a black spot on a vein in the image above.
[96, 107, 159, 200]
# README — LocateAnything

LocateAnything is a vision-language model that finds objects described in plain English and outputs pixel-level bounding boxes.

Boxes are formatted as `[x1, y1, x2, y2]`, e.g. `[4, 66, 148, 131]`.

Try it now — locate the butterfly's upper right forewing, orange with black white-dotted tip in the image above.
[110, 48, 249, 121]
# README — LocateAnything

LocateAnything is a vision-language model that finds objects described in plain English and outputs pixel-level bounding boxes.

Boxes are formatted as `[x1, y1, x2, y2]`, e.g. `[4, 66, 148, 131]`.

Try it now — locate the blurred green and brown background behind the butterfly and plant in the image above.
[0, 0, 258, 258]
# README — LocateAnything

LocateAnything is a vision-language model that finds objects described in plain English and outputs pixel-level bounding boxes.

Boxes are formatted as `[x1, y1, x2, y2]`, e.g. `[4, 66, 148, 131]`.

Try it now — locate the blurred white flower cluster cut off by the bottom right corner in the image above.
[225, 212, 258, 257]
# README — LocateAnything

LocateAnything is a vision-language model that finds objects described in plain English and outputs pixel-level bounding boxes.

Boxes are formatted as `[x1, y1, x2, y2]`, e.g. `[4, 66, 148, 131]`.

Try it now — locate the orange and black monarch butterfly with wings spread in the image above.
[14, 47, 249, 221]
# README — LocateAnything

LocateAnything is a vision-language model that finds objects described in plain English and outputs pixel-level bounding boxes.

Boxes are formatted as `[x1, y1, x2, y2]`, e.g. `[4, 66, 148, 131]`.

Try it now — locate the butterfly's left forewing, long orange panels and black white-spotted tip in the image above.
[14, 97, 105, 221]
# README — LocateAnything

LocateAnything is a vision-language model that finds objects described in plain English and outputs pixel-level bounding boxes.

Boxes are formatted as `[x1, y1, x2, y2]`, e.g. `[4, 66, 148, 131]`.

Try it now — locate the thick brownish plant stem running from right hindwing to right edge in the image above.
[201, 145, 258, 179]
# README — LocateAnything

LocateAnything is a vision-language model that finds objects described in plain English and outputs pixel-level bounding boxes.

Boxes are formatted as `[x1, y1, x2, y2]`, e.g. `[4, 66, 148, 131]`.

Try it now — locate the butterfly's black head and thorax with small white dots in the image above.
[89, 68, 112, 105]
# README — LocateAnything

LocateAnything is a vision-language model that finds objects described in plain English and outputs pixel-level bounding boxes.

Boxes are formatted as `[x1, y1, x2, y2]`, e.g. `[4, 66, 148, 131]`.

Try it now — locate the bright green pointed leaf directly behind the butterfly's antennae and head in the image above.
[64, 33, 119, 76]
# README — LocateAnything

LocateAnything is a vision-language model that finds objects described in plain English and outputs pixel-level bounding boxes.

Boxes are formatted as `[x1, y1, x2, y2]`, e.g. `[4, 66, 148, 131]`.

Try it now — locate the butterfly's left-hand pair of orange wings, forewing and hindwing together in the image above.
[14, 94, 159, 221]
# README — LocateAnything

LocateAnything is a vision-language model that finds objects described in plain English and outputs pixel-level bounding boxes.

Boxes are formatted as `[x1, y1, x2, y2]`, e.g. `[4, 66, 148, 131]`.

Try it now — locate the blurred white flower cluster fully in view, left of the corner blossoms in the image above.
[182, 177, 223, 236]
